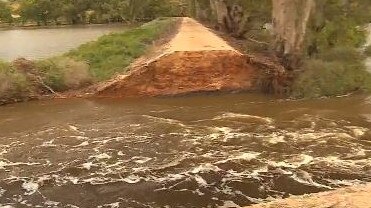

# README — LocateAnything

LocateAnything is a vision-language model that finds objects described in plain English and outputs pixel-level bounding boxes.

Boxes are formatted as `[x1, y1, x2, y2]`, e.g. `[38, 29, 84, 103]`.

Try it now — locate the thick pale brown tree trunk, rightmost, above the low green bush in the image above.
[272, 0, 315, 70]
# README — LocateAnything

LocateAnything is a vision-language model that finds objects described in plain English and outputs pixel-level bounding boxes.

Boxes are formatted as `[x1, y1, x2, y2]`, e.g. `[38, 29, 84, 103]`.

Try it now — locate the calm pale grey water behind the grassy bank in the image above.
[0, 25, 126, 61]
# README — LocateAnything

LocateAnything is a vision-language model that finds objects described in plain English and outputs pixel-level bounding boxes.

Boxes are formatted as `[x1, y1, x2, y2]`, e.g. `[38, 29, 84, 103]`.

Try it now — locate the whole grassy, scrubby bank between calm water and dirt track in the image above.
[0, 18, 178, 104]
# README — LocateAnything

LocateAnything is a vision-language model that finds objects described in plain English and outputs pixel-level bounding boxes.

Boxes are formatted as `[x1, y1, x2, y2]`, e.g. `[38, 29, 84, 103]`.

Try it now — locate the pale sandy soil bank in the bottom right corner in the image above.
[248, 184, 371, 208]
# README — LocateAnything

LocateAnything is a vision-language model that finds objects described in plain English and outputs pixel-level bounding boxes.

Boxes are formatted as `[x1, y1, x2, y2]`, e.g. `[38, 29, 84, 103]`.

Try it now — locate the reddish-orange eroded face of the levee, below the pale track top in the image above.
[95, 50, 258, 97]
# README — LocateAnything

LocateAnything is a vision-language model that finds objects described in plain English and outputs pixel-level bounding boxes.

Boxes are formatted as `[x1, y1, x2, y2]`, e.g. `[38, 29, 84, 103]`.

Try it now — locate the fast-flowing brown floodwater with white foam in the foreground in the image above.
[0, 94, 371, 208]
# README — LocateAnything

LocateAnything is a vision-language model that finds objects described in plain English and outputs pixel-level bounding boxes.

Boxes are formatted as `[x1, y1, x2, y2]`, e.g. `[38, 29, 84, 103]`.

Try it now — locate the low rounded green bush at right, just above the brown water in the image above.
[292, 48, 371, 98]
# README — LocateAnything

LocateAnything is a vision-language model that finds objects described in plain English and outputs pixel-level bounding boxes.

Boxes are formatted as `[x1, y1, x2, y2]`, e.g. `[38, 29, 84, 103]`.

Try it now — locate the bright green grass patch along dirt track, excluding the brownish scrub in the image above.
[66, 18, 176, 80]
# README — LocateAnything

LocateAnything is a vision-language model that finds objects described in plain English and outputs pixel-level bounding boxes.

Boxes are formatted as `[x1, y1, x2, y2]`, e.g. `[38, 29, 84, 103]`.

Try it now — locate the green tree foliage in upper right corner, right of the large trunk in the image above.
[306, 0, 371, 56]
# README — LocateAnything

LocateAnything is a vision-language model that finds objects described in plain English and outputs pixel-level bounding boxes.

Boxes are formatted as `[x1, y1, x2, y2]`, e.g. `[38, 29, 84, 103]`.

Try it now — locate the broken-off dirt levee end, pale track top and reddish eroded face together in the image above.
[96, 18, 257, 97]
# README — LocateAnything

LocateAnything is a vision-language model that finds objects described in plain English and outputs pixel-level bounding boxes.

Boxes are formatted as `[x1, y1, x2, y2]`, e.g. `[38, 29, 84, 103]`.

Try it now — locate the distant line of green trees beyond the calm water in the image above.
[0, 0, 184, 25]
